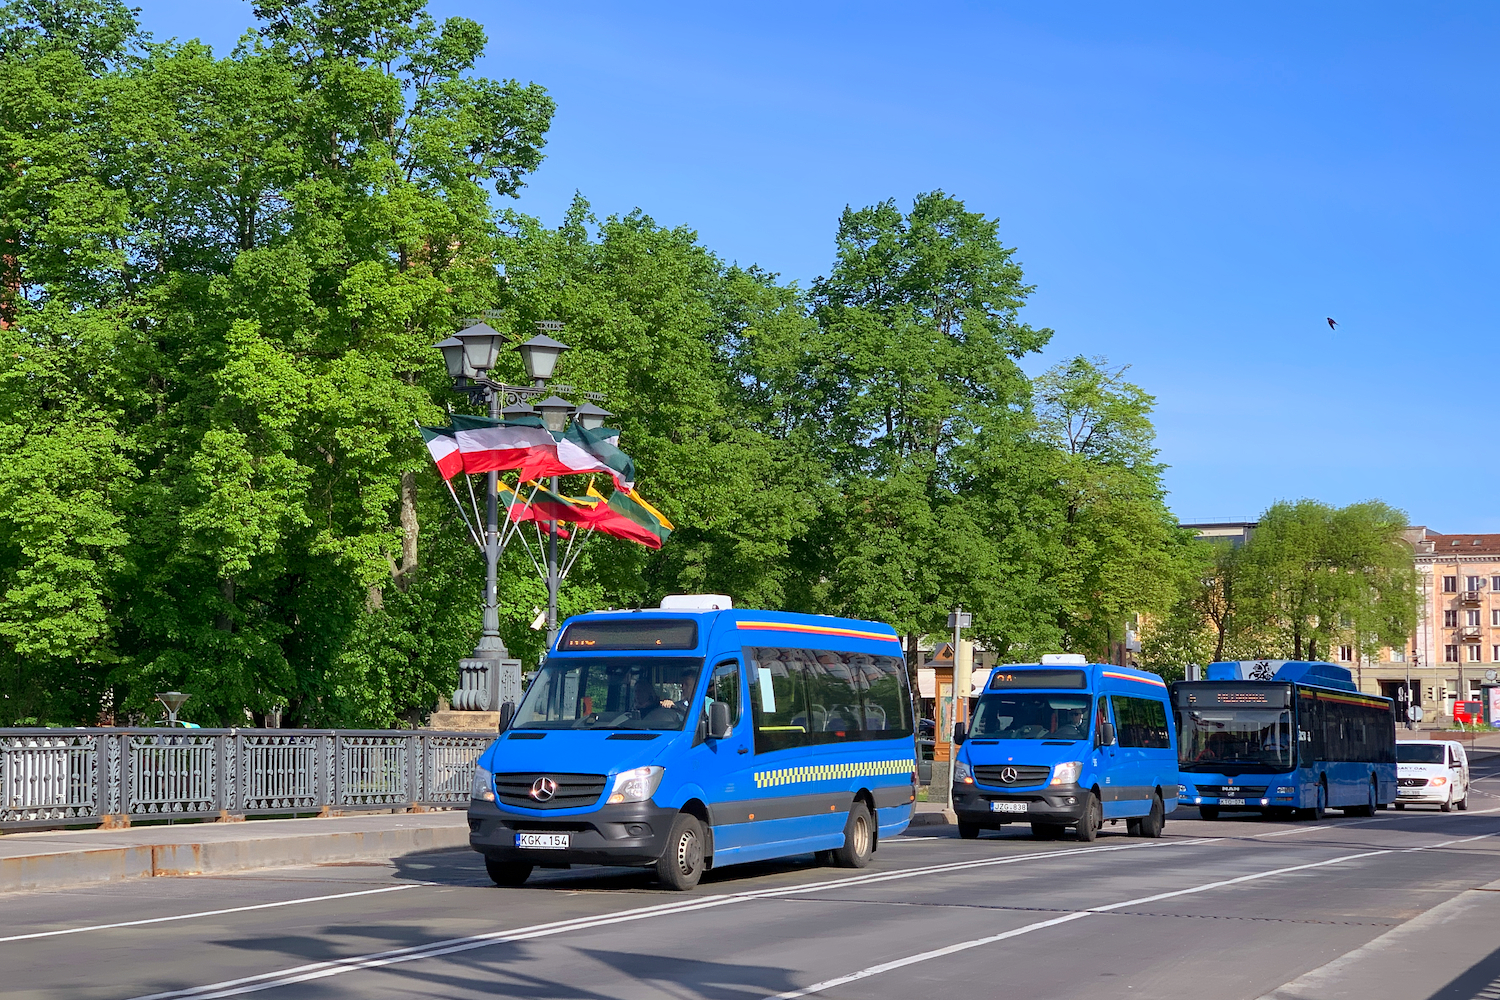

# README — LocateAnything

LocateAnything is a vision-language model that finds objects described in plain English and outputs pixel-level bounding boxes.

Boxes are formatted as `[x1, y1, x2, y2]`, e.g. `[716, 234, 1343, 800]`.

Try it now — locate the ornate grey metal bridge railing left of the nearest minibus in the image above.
[0, 729, 494, 829]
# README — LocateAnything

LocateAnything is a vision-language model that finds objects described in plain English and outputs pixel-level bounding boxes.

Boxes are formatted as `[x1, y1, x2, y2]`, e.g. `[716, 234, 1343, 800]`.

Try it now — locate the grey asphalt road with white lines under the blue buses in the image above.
[0, 765, 1500, 1000]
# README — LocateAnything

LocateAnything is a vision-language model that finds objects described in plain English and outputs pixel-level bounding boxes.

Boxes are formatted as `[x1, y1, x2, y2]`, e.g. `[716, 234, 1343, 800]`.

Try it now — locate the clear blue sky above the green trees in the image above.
[137, 0, 1500, 532]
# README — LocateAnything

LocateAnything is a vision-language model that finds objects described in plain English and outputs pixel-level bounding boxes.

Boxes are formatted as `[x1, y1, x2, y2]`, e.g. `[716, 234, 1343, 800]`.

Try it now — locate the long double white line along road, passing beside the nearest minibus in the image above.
[123, 838, 1218, 1000]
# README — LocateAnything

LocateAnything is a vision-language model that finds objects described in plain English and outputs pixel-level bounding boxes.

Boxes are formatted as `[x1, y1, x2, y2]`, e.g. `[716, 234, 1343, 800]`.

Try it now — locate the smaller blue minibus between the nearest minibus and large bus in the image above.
[953, 654, 1178, 841]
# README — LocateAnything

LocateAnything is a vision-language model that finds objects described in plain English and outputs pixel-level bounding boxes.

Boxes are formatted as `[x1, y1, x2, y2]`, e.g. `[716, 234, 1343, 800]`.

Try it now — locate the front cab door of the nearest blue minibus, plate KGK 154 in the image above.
[687, 658, 756, 864]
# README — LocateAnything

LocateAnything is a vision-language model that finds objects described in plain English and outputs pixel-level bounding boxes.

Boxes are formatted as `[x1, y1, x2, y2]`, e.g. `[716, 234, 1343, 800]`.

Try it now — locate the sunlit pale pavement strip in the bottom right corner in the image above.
[1260, 882, 1500, 1000]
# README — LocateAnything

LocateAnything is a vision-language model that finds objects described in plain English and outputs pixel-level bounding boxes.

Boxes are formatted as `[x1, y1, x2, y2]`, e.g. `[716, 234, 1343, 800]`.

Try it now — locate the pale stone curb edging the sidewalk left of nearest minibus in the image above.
[0, 825, 468, 892]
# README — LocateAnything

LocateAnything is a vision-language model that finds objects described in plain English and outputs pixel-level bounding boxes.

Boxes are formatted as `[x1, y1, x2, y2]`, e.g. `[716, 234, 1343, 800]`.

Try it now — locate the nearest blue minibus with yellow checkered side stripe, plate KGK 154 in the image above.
[468, 597, 917, 889]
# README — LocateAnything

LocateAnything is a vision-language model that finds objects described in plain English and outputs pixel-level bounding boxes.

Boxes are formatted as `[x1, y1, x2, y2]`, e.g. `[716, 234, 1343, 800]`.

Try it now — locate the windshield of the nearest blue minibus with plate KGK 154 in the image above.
[510, 655, 704, 730]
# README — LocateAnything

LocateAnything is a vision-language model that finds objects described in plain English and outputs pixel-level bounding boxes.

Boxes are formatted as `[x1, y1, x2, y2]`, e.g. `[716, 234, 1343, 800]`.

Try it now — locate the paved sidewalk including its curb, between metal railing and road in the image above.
[0, 810, 468, 892]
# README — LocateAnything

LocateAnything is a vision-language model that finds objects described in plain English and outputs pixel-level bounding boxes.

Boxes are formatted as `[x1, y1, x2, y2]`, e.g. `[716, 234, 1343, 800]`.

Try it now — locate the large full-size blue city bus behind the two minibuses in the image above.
[1172, 660, 1397, 820]
